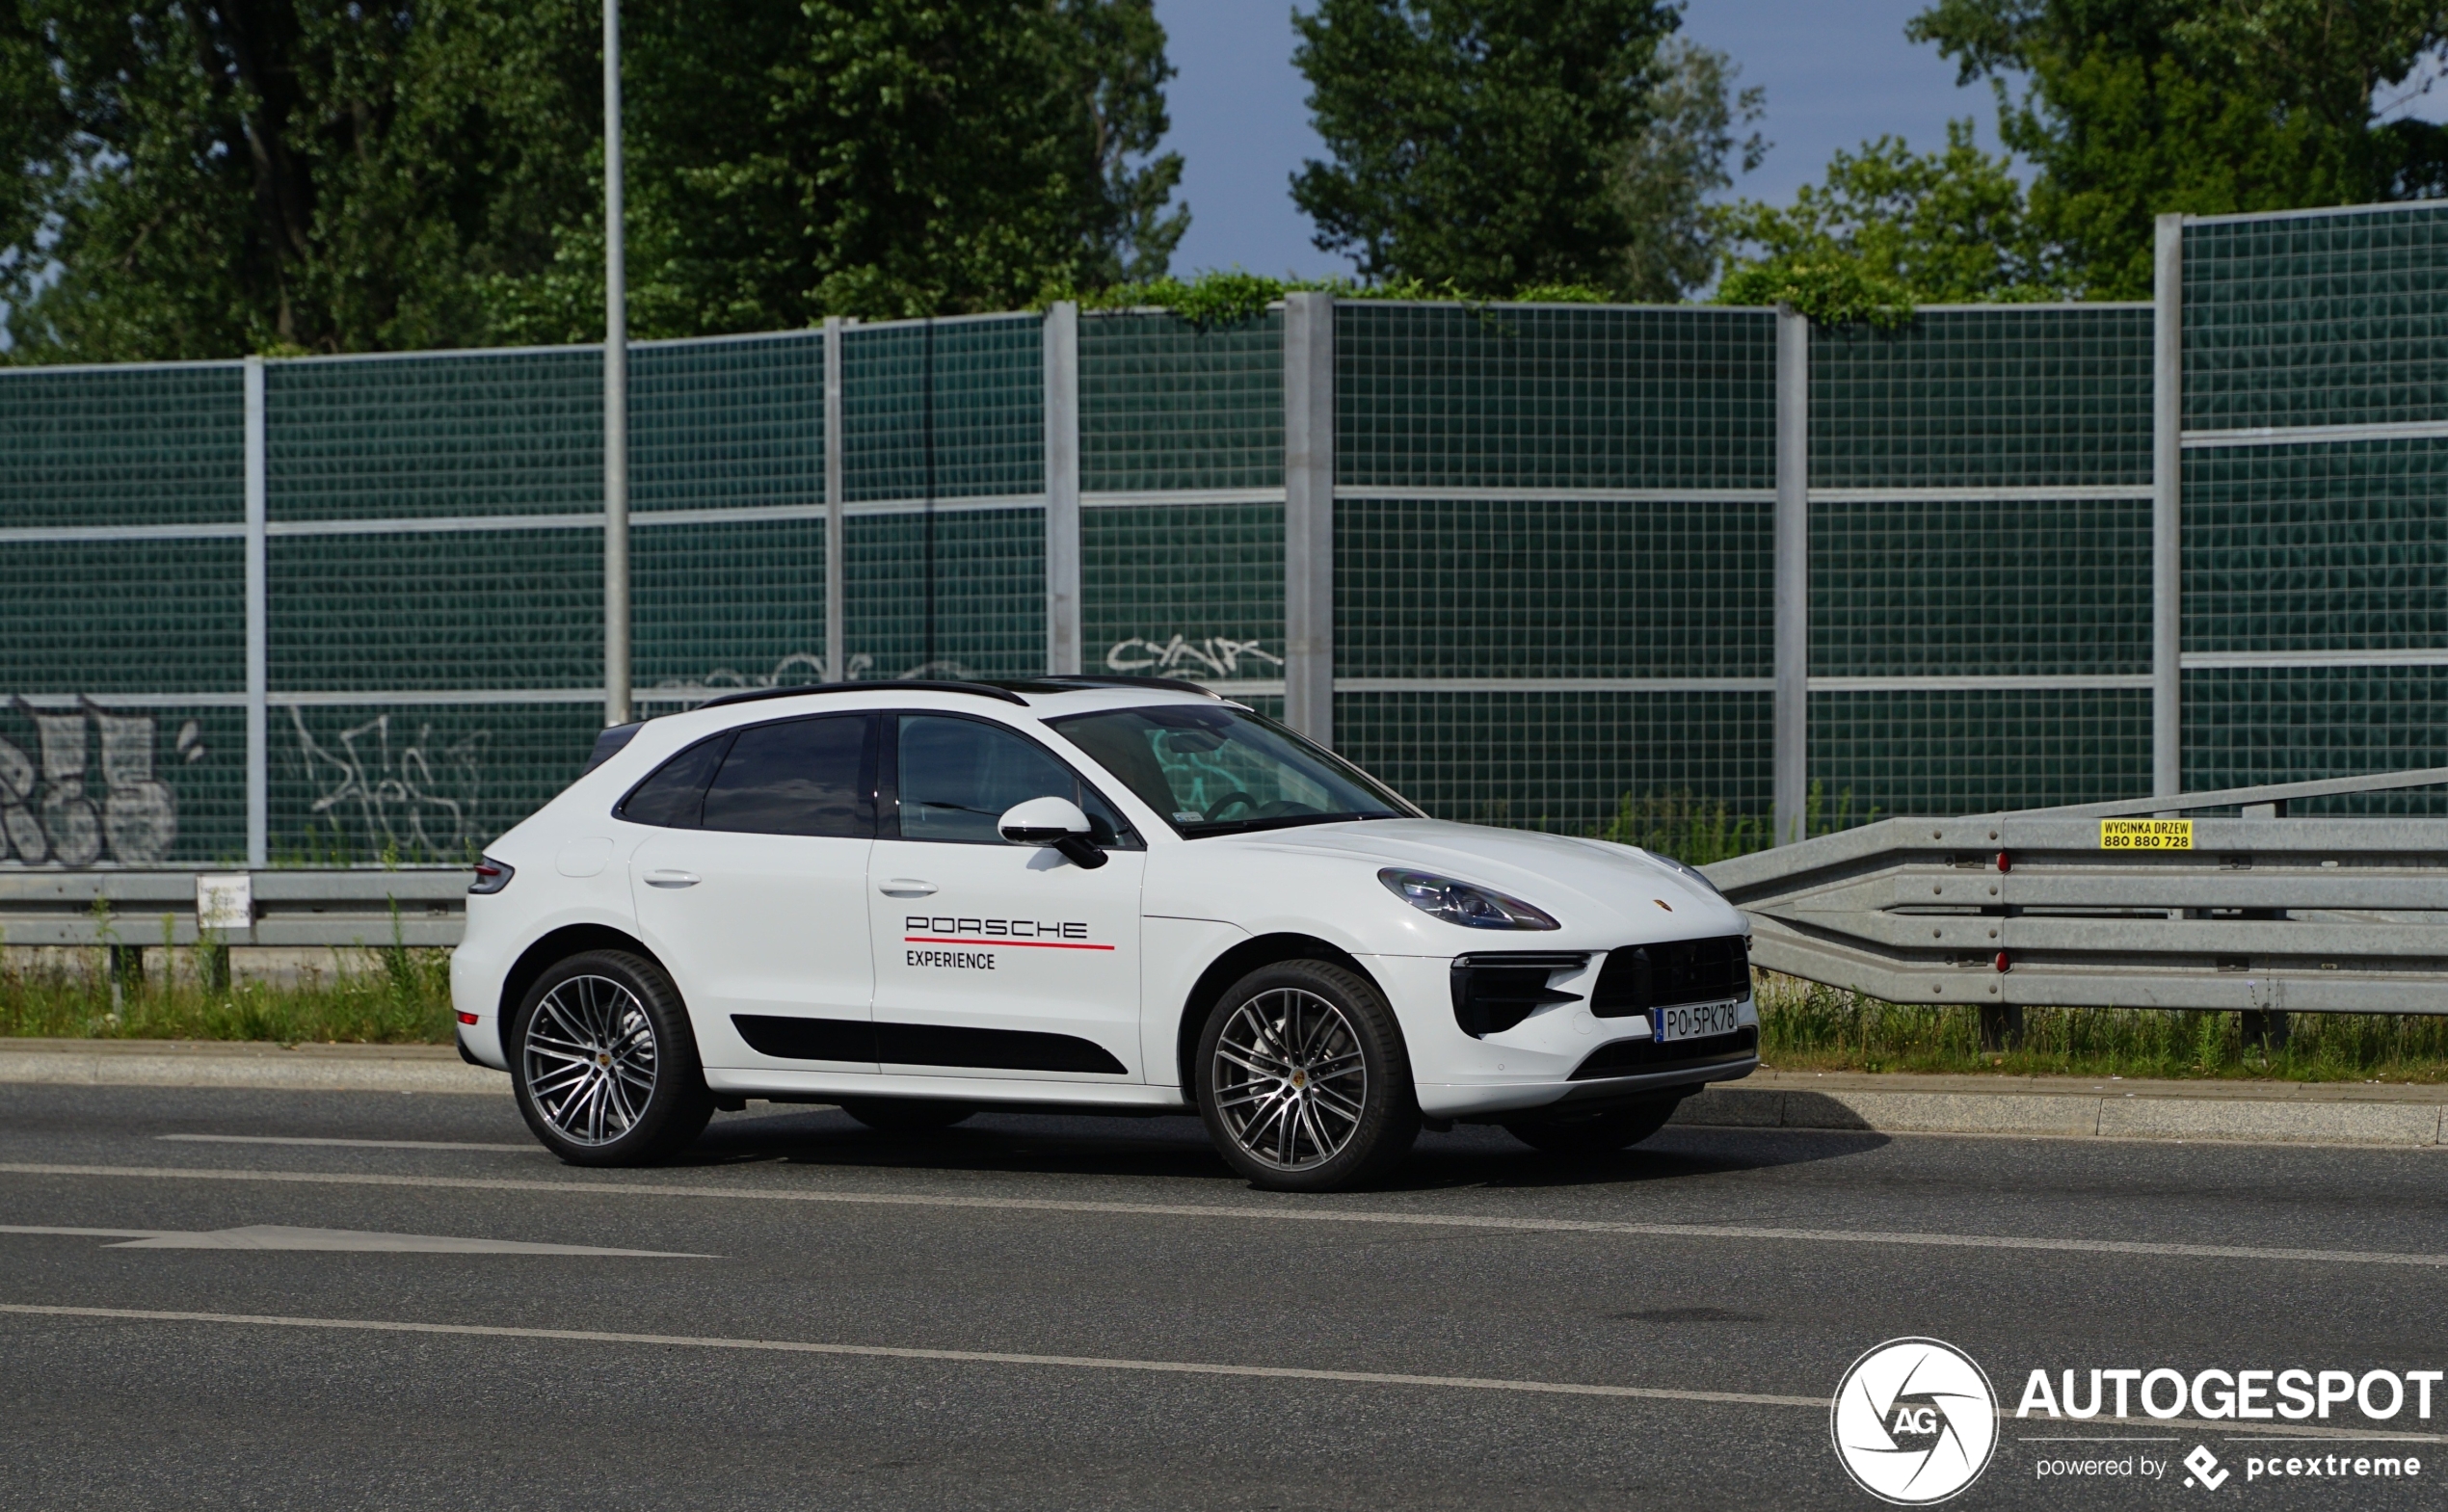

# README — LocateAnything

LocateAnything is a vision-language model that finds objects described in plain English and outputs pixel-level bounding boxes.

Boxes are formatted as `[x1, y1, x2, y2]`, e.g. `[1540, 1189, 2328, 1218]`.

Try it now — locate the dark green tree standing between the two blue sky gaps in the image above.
[1292, 0, 1677, 294]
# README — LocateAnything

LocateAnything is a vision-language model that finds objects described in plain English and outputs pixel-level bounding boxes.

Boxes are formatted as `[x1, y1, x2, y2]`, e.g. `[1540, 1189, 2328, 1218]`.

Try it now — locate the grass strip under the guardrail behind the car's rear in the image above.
[0, 947, 455, 1045]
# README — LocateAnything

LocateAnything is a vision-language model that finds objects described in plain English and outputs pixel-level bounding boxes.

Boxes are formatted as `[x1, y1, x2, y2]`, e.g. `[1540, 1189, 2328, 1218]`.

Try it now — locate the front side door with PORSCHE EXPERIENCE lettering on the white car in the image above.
[866, 712, 1146, 1081]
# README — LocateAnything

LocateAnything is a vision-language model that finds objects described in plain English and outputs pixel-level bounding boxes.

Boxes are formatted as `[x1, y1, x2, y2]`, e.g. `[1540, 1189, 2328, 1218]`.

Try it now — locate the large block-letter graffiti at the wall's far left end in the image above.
[0, 700, 203, 866]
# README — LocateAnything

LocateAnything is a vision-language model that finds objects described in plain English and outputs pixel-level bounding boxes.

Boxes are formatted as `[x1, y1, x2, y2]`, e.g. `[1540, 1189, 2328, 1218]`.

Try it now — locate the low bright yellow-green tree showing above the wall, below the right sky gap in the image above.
[1718, 119, 2066, 321]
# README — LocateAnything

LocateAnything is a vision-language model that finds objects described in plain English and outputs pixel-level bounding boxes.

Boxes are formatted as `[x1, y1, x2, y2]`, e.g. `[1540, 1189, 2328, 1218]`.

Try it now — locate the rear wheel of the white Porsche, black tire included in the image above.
[507, 949, 715, 1164]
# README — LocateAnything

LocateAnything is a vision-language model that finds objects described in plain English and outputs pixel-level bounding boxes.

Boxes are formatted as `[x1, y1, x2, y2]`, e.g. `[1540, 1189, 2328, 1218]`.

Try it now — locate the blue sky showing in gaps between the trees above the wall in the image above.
[1156, 0, 1998, 277]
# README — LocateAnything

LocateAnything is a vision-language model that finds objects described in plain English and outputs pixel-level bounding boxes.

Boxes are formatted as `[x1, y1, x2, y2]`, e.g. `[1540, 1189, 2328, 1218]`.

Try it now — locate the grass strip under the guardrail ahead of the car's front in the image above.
[1758, 971, 2448, 1081]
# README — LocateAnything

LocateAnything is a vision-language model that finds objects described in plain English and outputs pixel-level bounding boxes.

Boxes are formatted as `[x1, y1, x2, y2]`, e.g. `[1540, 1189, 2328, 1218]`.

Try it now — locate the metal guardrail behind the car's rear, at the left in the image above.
[0, 866, 475, 947]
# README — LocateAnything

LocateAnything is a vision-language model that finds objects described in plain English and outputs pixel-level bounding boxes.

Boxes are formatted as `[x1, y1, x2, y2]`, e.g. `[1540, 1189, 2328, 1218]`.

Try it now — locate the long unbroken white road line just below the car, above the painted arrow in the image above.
[0, 1162, 2448, 1270]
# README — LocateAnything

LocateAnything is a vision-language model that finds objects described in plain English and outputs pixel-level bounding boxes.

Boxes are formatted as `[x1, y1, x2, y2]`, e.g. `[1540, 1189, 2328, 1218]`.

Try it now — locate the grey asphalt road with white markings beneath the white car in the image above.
[0, 1086, 2448, 1509]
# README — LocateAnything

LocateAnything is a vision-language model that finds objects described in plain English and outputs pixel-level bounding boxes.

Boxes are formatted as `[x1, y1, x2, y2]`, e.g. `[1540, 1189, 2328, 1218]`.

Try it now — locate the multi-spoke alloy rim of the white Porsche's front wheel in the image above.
[1210, 986, 1369, 1172]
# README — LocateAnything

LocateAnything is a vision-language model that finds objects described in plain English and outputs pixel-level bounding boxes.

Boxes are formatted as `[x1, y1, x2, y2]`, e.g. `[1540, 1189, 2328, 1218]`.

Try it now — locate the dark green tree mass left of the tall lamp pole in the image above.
[0, 0, 593, 359]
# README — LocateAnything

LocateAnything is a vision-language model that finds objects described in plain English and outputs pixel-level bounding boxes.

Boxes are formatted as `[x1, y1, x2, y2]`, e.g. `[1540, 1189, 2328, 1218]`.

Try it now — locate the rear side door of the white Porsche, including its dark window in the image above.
[620, 714, 876, 1072]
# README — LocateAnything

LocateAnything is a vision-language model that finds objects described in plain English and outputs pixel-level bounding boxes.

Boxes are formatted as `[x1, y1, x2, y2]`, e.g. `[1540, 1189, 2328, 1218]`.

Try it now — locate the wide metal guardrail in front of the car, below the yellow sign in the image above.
[1704, 768, 2448, 1013]
